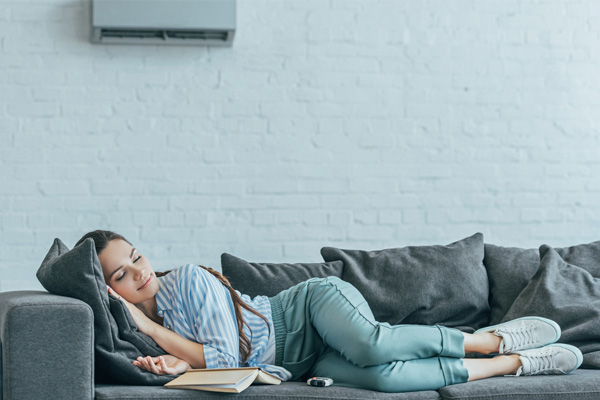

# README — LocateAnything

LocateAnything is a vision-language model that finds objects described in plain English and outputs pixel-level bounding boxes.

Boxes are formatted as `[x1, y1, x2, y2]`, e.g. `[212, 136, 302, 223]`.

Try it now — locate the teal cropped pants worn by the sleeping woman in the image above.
[270, 277, 469, 392]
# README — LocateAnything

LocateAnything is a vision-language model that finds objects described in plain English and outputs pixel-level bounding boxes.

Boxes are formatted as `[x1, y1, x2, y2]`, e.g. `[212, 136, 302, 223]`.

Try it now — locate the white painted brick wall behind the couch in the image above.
[0, 0, 600, 290]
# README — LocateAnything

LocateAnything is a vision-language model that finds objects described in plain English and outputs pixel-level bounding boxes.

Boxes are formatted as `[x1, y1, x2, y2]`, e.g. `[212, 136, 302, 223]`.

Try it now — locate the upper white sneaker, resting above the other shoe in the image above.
[475, 317, 560, 354]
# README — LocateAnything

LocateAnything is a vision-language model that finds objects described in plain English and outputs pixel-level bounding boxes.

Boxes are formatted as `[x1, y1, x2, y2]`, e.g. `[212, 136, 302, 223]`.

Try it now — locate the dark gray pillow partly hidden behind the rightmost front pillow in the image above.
[483, 241, 600, 325]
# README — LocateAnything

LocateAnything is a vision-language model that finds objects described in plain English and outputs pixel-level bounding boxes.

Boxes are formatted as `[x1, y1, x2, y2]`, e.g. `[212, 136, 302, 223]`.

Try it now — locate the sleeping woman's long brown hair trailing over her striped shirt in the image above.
[75, 230, 271, 362]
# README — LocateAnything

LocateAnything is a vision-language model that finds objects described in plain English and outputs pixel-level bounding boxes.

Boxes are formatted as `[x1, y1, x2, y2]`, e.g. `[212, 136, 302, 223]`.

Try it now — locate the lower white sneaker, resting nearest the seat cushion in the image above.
[515, 343, 583, 376]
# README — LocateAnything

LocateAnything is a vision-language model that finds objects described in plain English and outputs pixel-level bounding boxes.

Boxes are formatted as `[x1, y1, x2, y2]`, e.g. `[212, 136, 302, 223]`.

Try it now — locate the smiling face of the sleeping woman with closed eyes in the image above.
[98, 239, 158, 304]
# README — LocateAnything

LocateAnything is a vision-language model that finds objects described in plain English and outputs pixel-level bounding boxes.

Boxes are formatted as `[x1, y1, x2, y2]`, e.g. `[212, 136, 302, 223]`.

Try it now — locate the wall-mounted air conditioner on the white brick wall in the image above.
[92, 0, 236, 46]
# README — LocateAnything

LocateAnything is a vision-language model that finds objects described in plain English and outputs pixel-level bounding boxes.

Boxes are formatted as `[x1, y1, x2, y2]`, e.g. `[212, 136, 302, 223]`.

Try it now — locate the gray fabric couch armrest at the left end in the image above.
[0, 291, 94, 400]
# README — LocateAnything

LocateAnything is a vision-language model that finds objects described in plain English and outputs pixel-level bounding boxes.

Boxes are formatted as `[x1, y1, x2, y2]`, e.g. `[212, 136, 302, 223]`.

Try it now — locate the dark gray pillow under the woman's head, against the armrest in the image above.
[37, 238, 175, 385]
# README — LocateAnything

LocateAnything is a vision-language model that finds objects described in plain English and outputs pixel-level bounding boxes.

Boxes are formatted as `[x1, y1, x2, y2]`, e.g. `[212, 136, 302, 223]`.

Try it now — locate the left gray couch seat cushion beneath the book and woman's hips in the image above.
[96, 382, 440, 400]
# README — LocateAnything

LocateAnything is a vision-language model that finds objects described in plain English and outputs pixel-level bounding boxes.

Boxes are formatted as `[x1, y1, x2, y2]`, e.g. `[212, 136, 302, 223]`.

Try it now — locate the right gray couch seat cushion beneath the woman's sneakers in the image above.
[439, 369, 600, 400]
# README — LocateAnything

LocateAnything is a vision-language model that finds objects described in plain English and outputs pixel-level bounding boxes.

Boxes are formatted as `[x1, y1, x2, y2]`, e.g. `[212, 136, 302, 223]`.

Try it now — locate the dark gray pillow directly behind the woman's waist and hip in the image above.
[221, 253, 344, 297]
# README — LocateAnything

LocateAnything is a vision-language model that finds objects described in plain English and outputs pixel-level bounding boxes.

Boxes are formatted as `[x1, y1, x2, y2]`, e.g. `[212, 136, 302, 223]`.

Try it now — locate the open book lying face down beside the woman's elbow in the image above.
[165, 367, 281, 393]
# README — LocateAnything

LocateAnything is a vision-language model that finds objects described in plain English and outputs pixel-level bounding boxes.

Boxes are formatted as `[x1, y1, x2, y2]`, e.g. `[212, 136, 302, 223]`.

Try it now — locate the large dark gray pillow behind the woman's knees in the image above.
[321, 233, 489, 329]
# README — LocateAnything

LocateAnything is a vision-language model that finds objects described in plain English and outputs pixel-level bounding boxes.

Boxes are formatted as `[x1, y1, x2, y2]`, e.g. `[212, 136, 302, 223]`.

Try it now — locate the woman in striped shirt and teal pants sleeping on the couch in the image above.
[77, 230, 583, 392]
